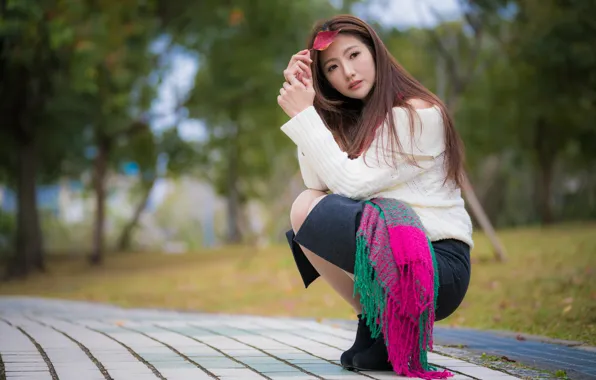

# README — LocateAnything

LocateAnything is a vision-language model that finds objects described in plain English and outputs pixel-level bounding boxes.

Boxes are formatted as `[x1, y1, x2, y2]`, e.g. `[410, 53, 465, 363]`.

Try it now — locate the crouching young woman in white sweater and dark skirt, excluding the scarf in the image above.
[278, 15, 473, 378]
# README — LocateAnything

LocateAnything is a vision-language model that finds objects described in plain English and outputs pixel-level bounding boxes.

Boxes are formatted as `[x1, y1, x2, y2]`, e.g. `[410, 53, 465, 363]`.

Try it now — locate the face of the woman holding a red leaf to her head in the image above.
[319, 33, 376, 100]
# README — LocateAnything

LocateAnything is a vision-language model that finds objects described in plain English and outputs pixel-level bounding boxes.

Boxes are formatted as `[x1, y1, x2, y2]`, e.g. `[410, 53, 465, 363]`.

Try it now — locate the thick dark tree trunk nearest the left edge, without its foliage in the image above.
[9, 138, 44, 277]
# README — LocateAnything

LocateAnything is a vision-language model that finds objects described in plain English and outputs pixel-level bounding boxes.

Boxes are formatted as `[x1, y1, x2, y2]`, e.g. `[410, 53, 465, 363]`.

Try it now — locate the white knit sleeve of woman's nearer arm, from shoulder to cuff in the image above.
[281, 106, 444, 199]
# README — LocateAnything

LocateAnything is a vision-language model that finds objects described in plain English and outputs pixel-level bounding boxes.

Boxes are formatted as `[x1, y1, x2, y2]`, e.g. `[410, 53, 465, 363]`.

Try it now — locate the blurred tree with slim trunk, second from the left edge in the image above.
[60, 0, 161, 264]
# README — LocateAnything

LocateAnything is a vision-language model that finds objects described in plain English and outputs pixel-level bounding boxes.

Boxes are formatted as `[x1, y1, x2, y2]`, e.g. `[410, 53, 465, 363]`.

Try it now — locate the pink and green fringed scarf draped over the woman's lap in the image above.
[354, 198, 453, 379]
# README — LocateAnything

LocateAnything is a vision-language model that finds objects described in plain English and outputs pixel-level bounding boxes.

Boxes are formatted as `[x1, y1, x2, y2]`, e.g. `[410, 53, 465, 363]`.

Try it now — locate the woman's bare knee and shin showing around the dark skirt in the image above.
[290, 190, 362, 314]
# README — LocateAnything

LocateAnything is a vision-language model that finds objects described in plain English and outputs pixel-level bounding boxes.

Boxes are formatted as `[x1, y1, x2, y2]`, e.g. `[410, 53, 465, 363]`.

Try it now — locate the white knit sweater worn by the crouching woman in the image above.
[281, 106, 473, 247]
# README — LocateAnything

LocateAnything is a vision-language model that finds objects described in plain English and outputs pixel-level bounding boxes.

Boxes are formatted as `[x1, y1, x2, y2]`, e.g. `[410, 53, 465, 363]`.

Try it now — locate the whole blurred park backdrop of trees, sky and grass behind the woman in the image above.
[0, 0, 596, 344]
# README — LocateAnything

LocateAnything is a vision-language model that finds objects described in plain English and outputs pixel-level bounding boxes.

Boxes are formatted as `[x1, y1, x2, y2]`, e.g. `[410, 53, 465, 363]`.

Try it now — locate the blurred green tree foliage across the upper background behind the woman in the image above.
[0, 0, 596, 273]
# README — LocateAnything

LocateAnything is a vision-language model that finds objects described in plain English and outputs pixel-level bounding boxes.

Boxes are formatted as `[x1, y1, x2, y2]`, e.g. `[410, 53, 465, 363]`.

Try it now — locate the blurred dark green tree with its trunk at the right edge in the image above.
[470, 0, 596, 224]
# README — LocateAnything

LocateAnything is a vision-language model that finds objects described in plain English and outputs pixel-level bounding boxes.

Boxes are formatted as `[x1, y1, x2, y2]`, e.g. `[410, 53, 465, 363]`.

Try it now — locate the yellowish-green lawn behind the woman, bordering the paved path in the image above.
[0, 224, 596, 345]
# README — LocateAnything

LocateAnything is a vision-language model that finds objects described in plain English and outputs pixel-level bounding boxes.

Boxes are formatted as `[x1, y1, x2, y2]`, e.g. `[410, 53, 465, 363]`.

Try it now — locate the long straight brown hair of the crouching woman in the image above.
[308, 15, 464, 186]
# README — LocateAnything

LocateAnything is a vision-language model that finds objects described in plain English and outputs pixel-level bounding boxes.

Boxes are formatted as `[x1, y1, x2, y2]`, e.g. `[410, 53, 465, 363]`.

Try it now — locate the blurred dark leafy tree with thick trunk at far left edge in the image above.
[0, 0, 86, 276]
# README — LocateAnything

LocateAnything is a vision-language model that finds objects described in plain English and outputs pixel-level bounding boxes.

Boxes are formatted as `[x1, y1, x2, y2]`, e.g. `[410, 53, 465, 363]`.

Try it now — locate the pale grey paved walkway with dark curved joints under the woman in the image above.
[0, 297, 517, 380]
